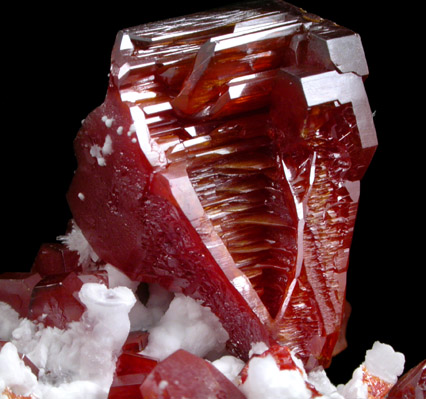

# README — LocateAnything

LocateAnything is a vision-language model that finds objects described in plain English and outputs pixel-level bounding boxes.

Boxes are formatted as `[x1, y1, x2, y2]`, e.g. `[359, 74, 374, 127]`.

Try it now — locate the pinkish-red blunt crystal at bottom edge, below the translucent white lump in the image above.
[140, 350, 245, 399]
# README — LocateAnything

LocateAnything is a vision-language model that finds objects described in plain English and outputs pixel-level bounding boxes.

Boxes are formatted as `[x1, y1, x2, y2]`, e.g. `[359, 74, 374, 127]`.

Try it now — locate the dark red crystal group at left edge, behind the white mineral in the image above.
[0, 243, 108, 329]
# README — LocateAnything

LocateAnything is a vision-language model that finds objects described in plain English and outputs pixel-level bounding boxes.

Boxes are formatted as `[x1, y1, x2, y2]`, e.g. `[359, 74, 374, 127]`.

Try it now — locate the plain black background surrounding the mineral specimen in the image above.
[0, 0, 426, 384]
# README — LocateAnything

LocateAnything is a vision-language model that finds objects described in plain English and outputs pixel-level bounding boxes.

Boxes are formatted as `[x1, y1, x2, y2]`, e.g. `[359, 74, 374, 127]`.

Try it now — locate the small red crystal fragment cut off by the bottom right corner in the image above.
[386, 359, 426, 399]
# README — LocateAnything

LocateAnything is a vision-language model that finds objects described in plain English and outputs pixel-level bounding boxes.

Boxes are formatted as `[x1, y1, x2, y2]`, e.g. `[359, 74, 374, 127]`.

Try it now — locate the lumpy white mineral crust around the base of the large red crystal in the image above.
[0, 282, 410, 399]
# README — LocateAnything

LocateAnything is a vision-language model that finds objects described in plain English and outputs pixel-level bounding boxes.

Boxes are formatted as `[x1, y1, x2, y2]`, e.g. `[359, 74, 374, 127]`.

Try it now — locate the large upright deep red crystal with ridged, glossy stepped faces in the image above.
[67, 1, 377, 368]
